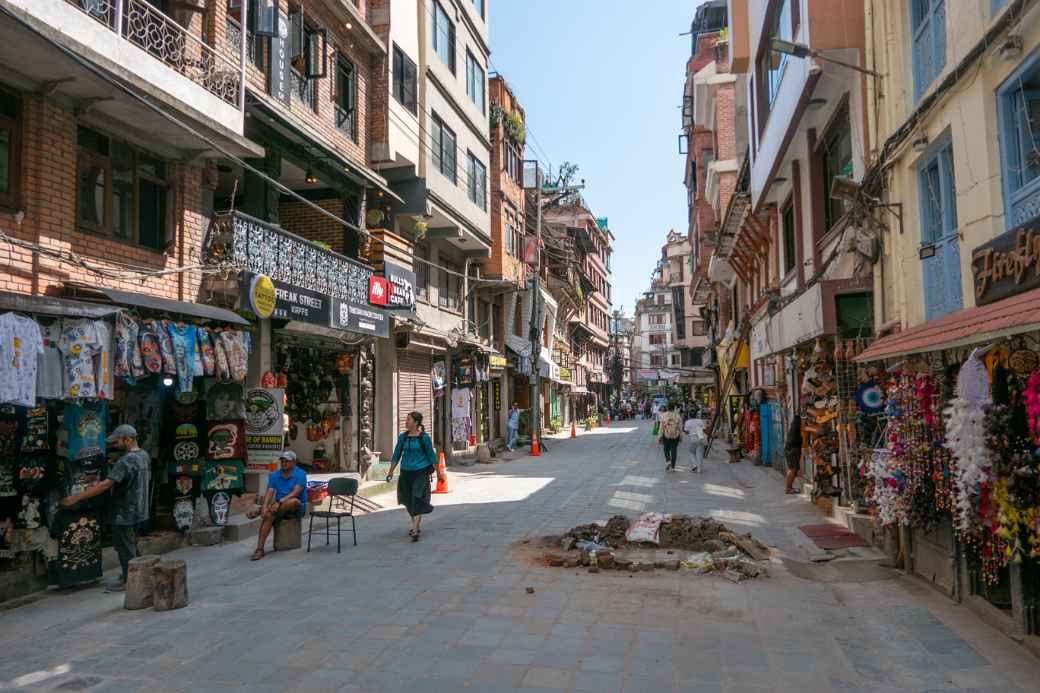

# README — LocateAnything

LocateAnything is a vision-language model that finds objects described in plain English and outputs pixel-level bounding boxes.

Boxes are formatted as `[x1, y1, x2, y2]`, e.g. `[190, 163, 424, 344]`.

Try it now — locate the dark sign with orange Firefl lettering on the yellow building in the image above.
[971, 224, 1040, 306]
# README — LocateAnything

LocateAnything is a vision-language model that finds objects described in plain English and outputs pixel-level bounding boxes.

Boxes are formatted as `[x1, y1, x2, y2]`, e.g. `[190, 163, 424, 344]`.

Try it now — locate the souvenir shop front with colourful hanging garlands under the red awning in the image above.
[853, 277, 1040, 635]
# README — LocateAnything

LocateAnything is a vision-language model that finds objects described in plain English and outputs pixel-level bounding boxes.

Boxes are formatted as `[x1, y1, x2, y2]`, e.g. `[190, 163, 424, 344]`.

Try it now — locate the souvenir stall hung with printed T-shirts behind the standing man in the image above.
[0, 289, 253, 587]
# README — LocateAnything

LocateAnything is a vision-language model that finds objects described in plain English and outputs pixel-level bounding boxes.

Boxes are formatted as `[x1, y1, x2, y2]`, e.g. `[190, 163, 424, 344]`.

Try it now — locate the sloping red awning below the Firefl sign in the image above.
[855, 288, 1040, 363]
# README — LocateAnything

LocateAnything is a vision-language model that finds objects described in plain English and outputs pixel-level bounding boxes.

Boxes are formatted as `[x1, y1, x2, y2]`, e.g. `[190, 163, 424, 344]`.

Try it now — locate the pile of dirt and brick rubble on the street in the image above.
[542, 513, 770, 582]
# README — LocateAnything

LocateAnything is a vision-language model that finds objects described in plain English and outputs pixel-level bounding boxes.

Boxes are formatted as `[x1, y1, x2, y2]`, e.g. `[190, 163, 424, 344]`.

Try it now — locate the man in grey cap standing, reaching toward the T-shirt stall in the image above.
[61, 424, 152, 592]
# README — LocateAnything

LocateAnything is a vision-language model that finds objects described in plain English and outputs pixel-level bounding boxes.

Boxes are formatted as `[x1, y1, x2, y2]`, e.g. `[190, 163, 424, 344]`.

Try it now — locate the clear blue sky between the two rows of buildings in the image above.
[489, 0, 701, 314]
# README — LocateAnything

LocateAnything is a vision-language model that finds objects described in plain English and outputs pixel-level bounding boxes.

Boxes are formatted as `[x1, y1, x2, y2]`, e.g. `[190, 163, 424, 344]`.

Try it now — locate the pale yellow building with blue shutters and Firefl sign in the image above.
[848, 0, 1040, 616]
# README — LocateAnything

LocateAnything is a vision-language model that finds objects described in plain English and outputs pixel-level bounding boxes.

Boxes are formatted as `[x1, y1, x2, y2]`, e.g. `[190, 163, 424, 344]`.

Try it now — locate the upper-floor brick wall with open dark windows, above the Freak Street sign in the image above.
[210, 0, 374, 164]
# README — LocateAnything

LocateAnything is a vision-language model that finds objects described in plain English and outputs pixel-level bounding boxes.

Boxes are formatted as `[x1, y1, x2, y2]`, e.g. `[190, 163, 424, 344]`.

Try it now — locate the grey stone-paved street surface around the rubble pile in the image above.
[0, 421, 1040, 693]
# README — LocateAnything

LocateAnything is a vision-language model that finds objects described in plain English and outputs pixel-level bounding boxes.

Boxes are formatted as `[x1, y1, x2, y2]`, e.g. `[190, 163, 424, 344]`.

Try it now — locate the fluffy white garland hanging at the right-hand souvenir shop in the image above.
[944, 396, 992, 533]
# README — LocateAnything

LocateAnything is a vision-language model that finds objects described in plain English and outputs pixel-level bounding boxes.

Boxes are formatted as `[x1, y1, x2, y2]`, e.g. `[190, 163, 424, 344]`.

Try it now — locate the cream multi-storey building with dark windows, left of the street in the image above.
[370, 0, 490, 454]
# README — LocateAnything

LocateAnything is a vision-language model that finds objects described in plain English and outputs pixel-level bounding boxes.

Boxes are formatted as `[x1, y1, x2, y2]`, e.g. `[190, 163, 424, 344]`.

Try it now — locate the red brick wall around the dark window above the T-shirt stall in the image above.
[0, 95, 205, 301]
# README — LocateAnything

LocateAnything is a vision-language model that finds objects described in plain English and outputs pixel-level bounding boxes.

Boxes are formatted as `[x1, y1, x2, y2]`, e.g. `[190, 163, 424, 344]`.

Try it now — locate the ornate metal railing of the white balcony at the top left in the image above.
[66, 0, 241, 106]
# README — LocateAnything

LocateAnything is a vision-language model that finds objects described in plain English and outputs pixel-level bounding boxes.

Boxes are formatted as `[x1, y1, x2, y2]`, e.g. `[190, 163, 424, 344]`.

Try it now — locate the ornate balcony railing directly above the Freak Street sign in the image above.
[203, 212, 373, 304]
